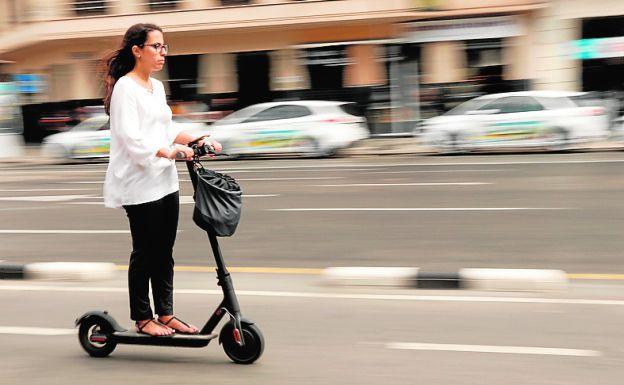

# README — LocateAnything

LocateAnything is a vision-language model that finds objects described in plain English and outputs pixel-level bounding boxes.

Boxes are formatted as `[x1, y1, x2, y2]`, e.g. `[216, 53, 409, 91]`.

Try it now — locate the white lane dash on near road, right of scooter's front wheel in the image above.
[386, 342, 602, 357]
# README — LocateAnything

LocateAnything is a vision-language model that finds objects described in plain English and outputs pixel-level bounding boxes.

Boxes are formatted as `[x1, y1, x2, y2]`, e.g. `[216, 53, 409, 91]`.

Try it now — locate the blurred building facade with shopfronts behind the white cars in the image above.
[0, 0, 624, 153]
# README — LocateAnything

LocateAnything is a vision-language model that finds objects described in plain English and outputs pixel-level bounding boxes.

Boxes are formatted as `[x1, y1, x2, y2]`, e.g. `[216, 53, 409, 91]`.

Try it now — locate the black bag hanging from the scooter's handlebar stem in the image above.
[193, 167, 243, 237]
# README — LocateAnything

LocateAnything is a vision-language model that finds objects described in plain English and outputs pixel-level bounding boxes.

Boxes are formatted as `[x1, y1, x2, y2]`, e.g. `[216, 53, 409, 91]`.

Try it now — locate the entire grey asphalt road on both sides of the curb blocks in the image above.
[0, 152, 624, 385]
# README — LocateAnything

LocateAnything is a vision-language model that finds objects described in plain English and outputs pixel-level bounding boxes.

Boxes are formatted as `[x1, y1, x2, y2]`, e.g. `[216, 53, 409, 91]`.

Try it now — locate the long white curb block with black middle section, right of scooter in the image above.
[321, 267, 568, 291]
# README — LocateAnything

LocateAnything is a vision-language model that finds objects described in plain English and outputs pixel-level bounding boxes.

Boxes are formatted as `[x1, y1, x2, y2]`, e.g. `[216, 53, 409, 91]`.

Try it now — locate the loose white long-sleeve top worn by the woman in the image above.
[103, 76, 180, 208]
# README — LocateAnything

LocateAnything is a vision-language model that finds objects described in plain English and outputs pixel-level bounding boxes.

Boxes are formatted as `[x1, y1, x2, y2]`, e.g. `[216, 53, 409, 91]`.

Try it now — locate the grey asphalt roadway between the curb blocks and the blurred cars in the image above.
[0, 152, 624, 273]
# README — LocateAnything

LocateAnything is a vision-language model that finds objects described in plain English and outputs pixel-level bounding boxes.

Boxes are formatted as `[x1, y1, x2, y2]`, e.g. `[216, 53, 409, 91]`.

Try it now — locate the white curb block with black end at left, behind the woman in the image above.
[0, 262, 115, 281]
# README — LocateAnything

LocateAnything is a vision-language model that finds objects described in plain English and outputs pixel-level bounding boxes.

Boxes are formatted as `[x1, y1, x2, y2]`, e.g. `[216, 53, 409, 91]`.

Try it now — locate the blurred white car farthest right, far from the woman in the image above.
[422, 91, 610, 151]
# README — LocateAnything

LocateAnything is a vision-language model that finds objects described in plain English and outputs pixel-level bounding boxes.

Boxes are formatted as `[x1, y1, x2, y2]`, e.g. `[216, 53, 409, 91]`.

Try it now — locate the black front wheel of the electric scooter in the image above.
[219, 322, 264, 365]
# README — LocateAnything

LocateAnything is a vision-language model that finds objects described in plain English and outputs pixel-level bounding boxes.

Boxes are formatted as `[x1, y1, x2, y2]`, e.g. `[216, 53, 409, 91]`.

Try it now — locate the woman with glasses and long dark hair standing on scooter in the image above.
[104, 24, 221, 336]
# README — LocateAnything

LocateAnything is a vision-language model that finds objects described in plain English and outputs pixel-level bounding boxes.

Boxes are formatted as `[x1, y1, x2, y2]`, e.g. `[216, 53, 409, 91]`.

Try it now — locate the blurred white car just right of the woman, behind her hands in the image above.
[191, 101, 369, 156]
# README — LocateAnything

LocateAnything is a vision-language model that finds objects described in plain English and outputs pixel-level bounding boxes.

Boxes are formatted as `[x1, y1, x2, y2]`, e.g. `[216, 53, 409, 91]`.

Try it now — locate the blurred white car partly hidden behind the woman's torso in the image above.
[42, 114, 205, 160]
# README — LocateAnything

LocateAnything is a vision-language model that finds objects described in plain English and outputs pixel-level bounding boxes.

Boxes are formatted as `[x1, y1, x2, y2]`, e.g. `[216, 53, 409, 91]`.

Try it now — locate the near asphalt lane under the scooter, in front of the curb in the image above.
[0, 272, 624, 385]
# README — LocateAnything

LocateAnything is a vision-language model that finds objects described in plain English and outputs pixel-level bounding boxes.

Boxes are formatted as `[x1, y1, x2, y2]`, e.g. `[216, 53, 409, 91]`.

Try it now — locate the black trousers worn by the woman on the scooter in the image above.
[124, 191, 180, 321]
